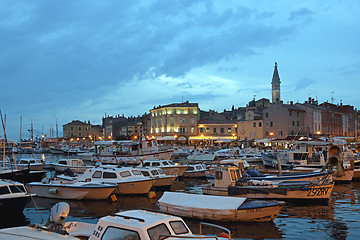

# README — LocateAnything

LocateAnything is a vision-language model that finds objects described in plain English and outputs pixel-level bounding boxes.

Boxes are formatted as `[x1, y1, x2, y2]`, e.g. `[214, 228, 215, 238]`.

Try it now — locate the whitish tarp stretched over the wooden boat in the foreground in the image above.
[158, 192, 246, 210]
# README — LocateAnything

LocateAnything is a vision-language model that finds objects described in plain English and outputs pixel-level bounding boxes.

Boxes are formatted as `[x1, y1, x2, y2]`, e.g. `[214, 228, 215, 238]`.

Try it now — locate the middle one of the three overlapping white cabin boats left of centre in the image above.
[137, 167, 178, 187]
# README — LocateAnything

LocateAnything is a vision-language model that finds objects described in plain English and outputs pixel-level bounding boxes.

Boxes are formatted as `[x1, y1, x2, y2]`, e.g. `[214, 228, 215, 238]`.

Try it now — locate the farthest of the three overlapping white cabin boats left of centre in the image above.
[139, 159, 188, 177]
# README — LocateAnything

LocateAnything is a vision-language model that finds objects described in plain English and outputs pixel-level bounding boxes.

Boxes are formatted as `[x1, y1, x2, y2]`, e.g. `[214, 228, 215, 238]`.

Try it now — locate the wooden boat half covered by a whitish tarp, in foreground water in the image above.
[158, 192, 284, 222]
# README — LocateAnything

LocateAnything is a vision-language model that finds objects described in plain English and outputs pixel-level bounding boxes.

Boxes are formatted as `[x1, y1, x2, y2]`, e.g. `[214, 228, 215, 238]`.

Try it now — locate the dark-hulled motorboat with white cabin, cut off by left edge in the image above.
[0, 179, 36, 214]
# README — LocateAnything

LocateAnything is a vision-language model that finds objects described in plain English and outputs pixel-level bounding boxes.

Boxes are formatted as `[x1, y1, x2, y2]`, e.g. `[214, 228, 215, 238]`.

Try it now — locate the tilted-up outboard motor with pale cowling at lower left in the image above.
[45, 202, 70, 235]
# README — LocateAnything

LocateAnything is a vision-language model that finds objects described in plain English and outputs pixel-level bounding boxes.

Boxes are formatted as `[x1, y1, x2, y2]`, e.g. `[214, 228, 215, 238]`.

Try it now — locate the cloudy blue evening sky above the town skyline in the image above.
[0, 0, 360, 140]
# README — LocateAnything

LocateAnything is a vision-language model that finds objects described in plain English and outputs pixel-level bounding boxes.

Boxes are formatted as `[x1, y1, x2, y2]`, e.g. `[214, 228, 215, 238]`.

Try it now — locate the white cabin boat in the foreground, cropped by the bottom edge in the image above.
[64, 210, 231, 240]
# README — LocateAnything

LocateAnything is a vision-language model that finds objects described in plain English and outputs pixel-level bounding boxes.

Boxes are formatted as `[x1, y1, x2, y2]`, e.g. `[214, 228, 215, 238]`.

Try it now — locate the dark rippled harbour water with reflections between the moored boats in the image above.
[0, 155, 360, 239]
